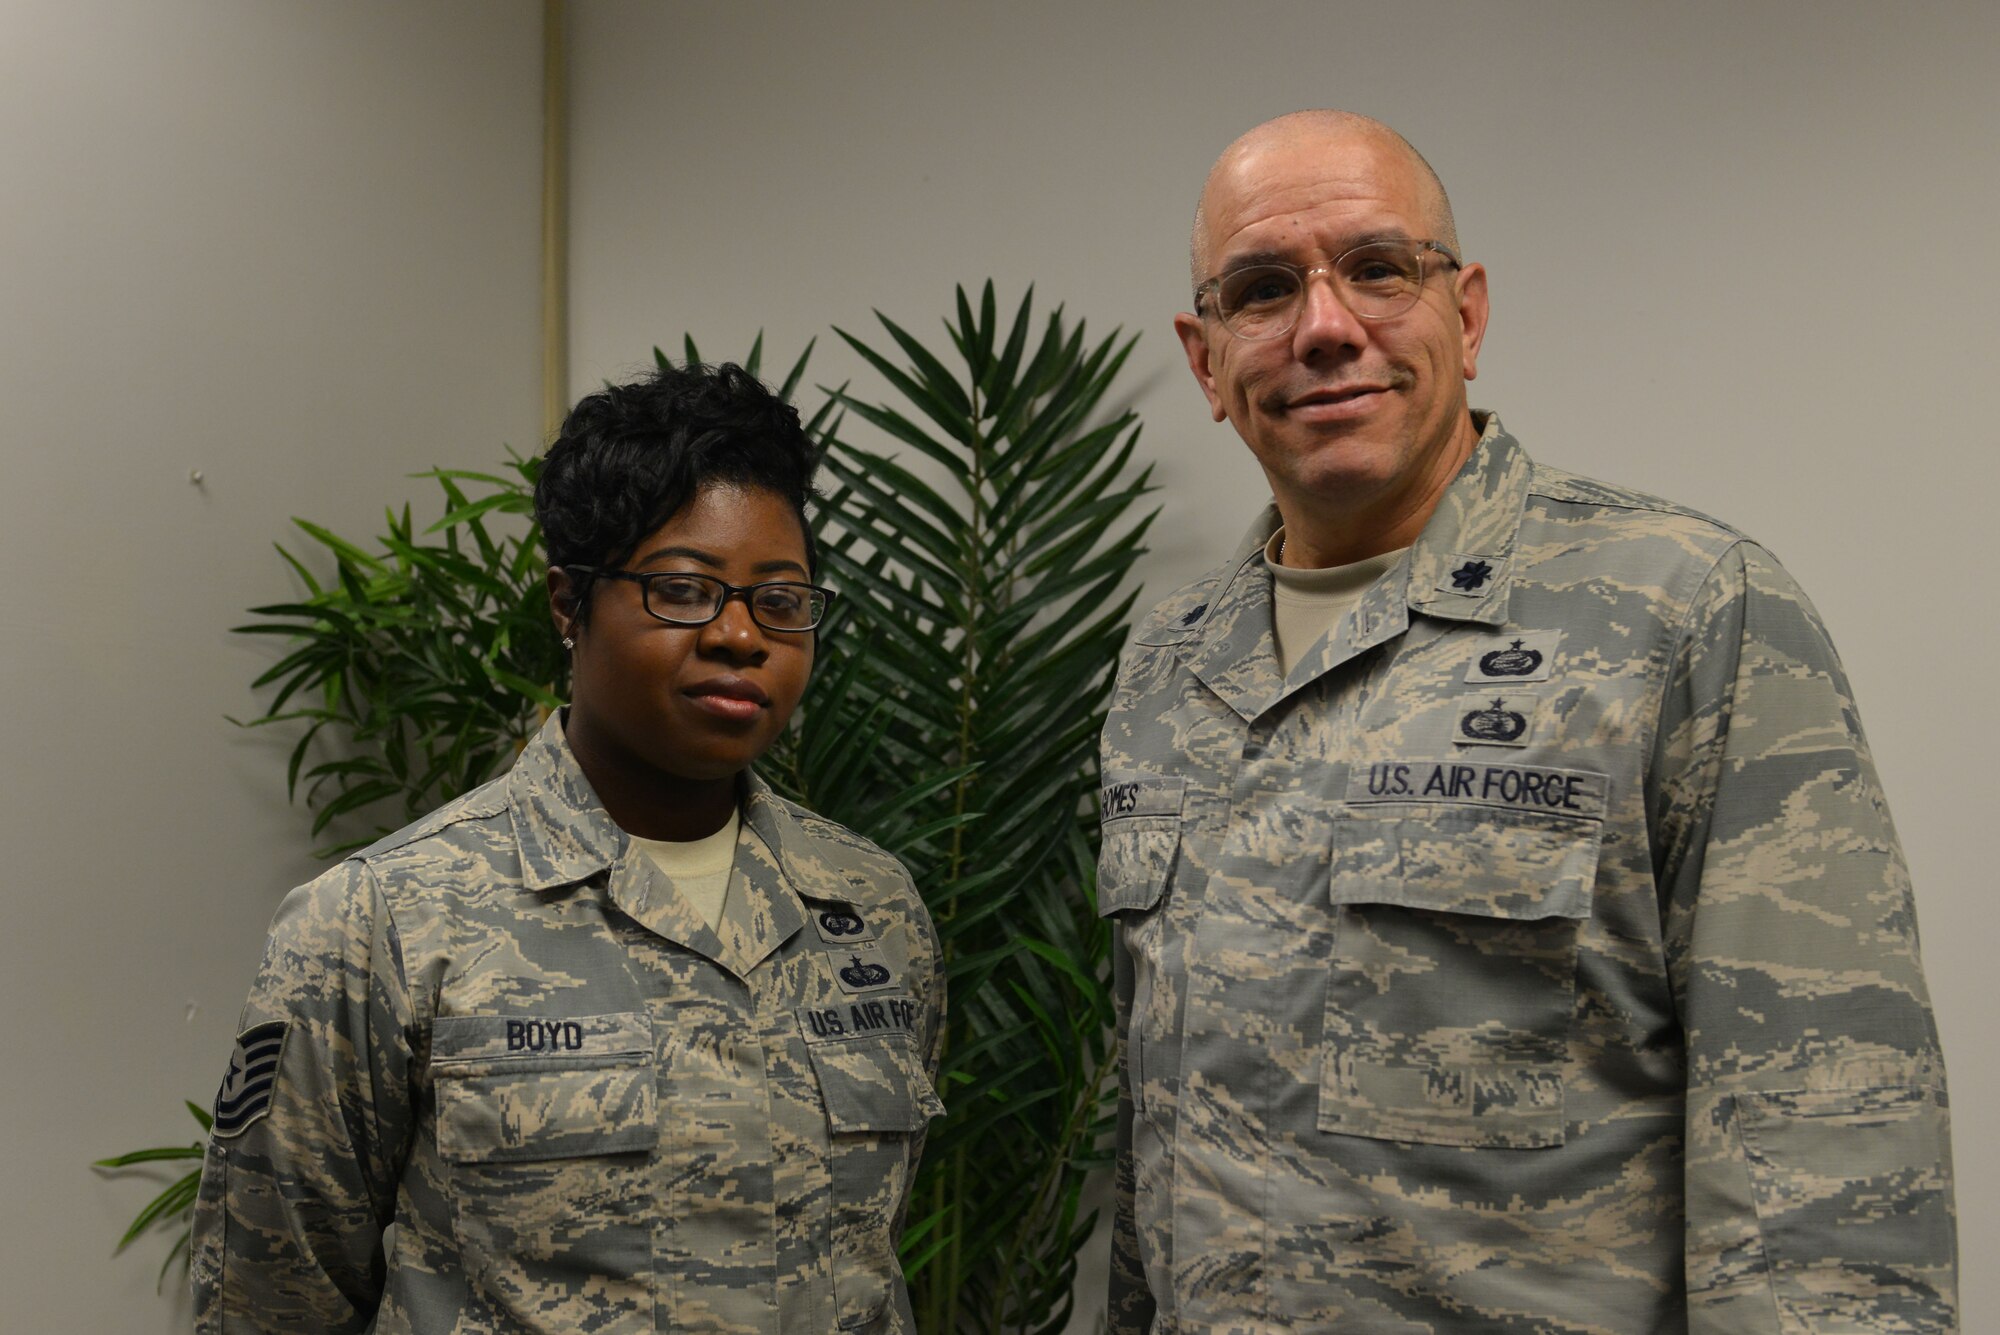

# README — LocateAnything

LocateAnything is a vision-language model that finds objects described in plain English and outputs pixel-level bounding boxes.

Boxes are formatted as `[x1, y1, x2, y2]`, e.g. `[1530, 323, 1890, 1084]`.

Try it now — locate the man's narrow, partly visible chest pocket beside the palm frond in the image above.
[1098, 771, 1186, 1115]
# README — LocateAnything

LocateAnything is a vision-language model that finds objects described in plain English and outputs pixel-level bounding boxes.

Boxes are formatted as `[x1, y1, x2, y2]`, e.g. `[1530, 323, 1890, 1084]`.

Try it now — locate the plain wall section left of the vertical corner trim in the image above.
[0, 0, 540, 1335]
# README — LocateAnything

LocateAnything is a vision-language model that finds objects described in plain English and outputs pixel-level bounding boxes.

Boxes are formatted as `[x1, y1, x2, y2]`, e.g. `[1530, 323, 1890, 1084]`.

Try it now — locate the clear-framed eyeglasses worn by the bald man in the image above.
[1194, 242, 1462, 338]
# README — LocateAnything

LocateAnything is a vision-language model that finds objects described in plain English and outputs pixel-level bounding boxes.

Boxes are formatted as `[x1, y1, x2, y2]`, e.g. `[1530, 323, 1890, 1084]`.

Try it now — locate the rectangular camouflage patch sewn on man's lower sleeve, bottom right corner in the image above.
[1736, 1087, 1958, 1331]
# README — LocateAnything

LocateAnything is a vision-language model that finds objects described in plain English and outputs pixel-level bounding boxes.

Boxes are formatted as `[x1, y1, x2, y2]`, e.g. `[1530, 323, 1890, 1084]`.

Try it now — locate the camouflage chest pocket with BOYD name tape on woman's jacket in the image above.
[430, 1011, 660, 1335]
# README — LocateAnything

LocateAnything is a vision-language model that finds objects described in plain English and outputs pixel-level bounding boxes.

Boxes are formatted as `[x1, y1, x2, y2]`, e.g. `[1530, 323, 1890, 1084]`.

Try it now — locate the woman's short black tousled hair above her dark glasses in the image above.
[534, 362, 820, 622]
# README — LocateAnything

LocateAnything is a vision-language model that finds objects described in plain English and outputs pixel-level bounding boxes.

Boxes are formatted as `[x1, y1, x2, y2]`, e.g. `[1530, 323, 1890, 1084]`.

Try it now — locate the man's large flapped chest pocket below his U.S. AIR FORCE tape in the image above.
[1318, 771, 1604, 1149]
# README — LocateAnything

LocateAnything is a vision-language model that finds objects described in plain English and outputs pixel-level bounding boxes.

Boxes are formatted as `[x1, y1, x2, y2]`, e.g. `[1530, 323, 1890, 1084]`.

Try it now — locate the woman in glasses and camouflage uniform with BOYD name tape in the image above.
[194, 366, 944, 1335]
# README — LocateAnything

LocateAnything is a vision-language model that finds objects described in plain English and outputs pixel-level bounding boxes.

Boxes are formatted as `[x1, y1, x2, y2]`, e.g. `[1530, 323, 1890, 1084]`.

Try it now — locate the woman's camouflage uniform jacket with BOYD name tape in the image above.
[192, 719, 944, 1335]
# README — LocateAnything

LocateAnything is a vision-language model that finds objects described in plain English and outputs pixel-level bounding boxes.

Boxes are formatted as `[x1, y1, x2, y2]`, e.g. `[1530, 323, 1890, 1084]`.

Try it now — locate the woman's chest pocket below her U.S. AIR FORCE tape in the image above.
[800, 1015, 944, 1331]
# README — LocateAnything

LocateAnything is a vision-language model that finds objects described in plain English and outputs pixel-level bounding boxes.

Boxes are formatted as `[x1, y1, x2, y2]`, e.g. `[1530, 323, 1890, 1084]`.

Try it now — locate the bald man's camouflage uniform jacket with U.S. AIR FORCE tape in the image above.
[1100, 418, 1956, 1335]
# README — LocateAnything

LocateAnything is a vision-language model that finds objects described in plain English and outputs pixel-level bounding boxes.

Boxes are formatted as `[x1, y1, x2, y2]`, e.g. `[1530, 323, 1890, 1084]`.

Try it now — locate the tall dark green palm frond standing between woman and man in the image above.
[782, 284, 1150, 1333]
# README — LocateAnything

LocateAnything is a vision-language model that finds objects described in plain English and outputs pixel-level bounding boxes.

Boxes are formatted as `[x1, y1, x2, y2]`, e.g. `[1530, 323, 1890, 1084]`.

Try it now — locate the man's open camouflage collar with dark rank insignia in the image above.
[1180, 412, 1534, 721]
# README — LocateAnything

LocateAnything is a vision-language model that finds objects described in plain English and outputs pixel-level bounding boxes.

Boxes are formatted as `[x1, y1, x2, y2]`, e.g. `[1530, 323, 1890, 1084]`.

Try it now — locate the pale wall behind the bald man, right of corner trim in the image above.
[572, 0, 2000, 1329]
